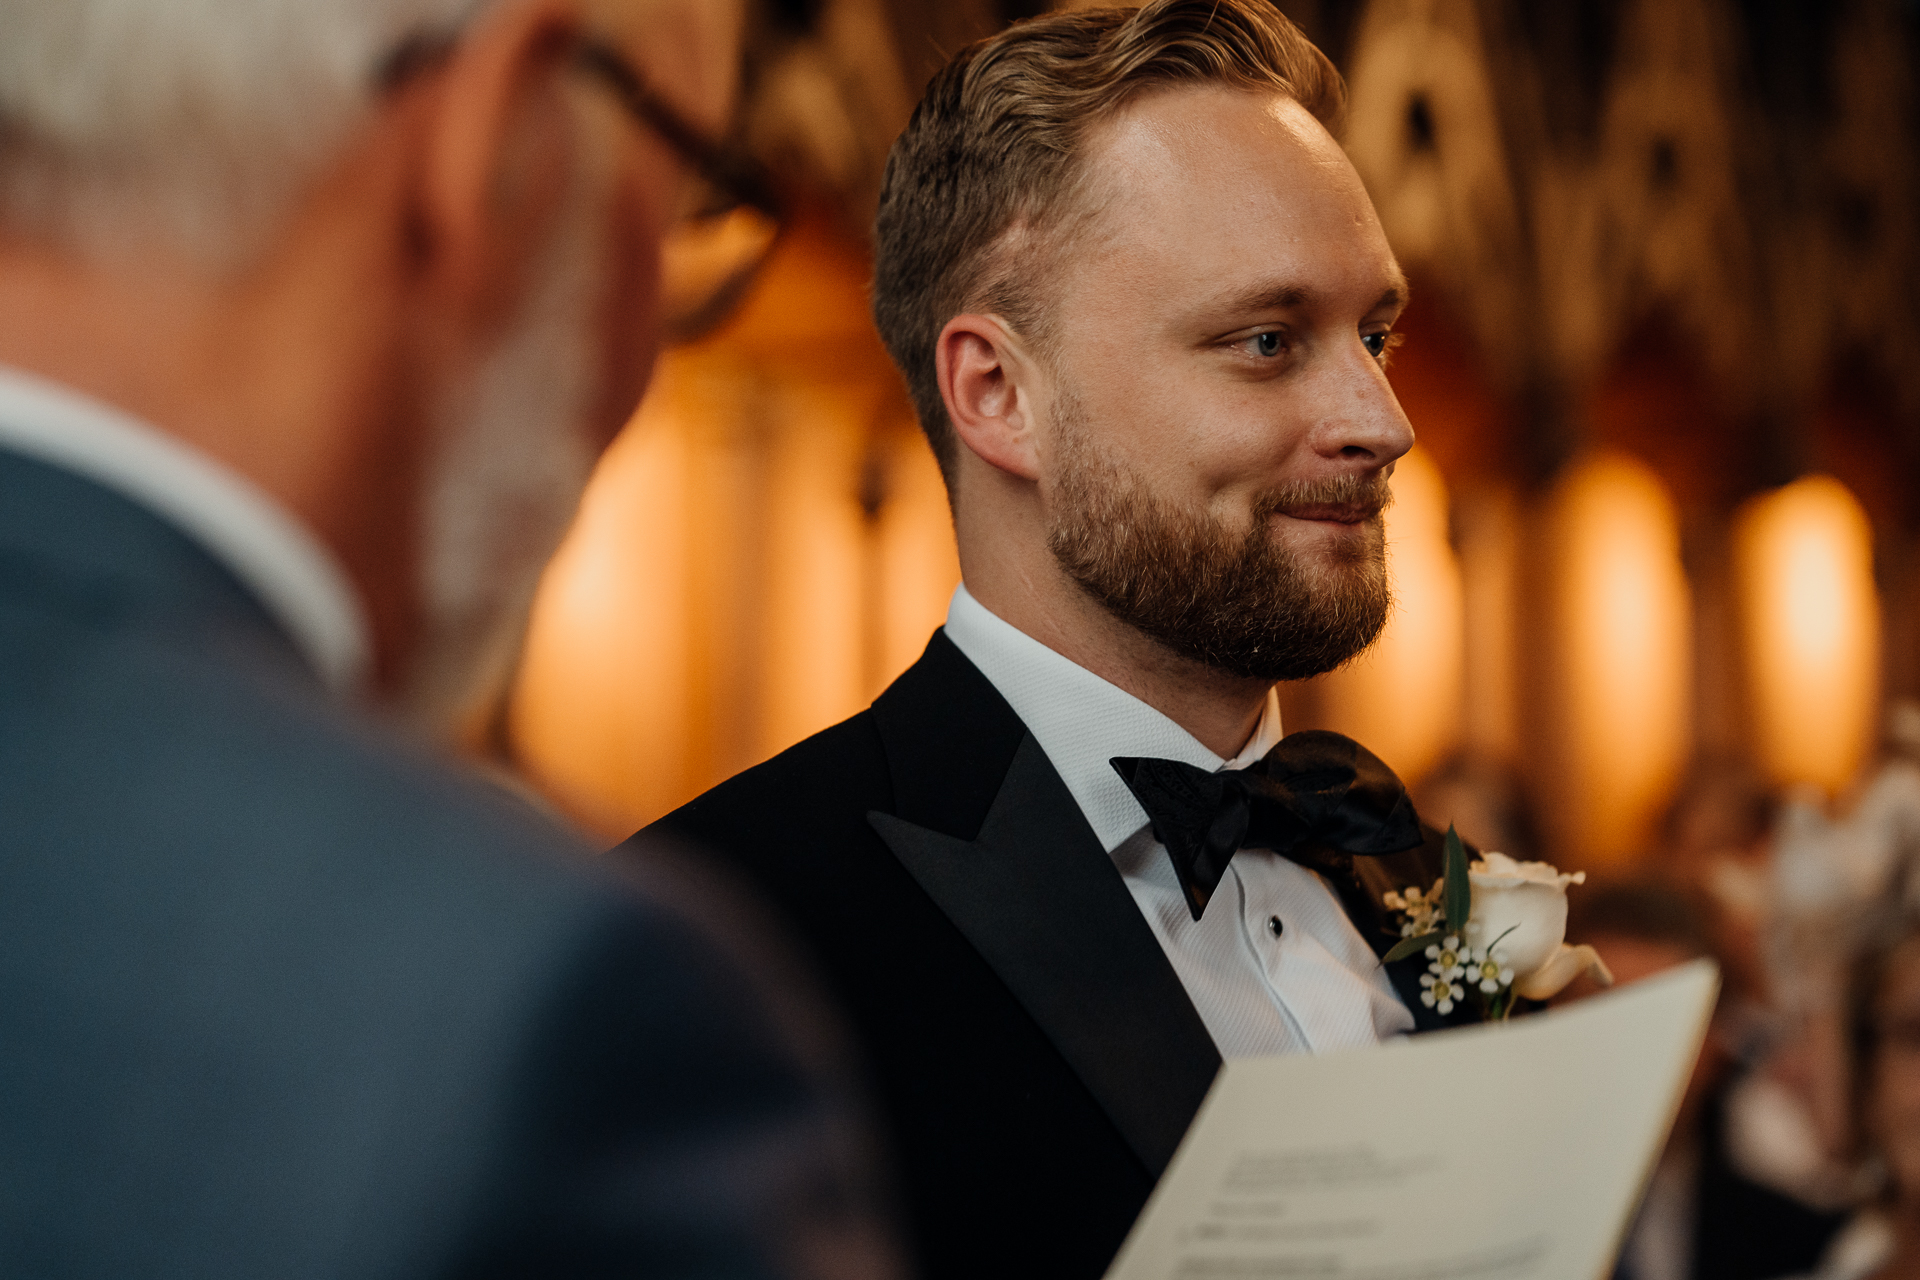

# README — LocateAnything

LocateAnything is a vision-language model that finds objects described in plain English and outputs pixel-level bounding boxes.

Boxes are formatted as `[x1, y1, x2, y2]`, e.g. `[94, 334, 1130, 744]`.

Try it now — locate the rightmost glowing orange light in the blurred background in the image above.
[1734, 476, 1880, 791]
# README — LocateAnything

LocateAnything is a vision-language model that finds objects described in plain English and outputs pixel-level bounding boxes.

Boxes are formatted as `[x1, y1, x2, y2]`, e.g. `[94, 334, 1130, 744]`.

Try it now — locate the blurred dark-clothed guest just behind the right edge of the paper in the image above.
[1561, 881, 1841, 1280]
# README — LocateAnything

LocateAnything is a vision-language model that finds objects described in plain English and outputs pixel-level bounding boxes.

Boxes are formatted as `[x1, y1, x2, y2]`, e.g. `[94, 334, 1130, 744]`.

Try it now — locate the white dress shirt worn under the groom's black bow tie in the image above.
[947, 585, 1413, 1057]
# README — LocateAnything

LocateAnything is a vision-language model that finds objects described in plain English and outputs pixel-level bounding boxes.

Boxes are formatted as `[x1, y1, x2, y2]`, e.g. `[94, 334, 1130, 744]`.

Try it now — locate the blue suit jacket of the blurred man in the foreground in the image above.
[0, 449, 883, 1280]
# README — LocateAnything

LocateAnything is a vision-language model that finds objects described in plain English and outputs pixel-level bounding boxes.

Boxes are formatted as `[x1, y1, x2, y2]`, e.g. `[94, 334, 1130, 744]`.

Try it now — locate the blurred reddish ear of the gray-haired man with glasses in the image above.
[409, 0, 582, 324]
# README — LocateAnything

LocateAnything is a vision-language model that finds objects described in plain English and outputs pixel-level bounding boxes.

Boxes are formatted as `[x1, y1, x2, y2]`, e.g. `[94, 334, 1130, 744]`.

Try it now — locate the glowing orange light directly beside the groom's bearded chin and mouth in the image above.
[1323, 447, 1463, 781]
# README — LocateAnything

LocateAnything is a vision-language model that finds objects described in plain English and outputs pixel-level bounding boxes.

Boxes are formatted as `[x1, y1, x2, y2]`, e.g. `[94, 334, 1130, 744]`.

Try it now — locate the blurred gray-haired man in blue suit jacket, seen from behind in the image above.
[0, 0, 891, 1278]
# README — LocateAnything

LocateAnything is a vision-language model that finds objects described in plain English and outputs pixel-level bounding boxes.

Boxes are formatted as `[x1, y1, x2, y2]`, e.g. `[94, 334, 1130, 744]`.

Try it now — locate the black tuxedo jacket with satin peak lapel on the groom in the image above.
[649, 631, 1438, 1280]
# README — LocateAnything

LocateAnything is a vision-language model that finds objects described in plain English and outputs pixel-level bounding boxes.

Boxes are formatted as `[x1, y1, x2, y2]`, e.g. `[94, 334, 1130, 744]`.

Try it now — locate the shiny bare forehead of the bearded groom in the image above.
[1069, 86, 1404, 320]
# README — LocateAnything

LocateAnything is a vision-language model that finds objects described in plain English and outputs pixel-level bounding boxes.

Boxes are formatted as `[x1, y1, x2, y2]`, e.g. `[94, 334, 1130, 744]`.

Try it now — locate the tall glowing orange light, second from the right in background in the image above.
[1538, 453, 1692, 865]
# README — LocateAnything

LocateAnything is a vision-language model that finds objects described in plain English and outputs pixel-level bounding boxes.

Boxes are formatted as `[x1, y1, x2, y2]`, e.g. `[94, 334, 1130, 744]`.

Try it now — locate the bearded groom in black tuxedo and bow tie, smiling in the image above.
[637, 0, 1436, 1278]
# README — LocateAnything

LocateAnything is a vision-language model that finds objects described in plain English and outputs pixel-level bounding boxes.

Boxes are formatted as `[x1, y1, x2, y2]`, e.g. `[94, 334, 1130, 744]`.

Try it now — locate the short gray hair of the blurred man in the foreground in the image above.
[0, 0, 495, 265]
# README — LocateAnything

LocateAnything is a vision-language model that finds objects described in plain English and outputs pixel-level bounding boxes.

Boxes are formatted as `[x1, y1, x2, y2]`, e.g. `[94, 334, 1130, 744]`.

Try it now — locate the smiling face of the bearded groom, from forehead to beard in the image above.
[1037, 88, 1413, 679]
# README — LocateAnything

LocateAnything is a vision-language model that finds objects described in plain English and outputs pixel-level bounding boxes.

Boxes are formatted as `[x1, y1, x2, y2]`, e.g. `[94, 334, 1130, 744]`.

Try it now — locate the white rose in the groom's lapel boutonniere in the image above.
[1467, 854, 1613, 1000]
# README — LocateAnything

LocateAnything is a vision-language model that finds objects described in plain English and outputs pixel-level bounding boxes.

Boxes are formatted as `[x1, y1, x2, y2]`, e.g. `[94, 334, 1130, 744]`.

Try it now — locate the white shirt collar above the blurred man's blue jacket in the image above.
[0, 365, 369, 693]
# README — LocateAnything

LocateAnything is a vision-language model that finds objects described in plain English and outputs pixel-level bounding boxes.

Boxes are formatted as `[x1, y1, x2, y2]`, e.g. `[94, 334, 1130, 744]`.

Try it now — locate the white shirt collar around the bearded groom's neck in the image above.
[947, 583, 1281, 852]
